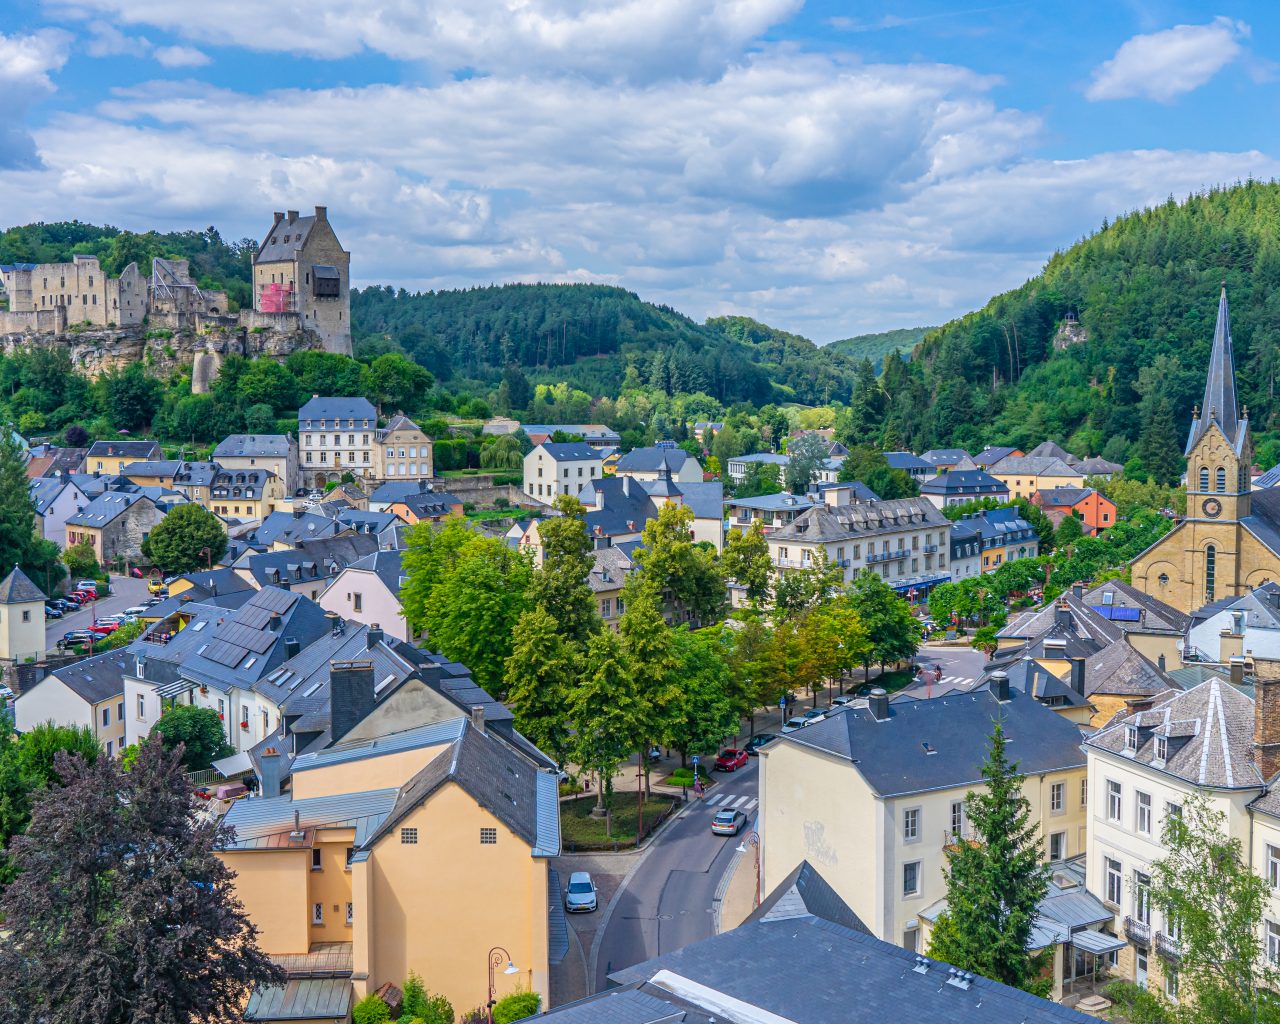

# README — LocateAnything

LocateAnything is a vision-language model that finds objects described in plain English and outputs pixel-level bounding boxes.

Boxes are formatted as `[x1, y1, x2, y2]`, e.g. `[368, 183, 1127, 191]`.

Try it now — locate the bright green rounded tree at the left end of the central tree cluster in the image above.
[422, 535, 532, 694]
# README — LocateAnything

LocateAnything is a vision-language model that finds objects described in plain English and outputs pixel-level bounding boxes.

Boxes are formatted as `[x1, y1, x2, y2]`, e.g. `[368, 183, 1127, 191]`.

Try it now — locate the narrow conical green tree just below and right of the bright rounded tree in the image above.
[506, 608, 579, 765]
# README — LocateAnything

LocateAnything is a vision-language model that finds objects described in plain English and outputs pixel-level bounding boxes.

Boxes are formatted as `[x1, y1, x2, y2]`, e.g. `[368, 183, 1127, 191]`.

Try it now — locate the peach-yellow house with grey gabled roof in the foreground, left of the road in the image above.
[221, 660, 561, 1020]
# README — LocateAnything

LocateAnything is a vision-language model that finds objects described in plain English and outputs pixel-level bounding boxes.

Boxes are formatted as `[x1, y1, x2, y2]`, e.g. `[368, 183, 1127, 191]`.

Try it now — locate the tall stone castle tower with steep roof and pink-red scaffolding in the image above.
[253, 206, 351, 356]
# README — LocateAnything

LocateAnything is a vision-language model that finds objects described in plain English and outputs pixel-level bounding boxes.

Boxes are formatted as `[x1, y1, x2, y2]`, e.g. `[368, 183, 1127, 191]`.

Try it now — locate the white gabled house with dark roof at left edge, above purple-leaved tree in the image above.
[14, 650, 133, 758]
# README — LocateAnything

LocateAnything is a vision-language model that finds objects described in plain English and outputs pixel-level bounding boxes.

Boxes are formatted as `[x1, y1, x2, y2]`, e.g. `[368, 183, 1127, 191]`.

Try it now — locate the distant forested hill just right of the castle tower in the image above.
[351, 284, 856, 404]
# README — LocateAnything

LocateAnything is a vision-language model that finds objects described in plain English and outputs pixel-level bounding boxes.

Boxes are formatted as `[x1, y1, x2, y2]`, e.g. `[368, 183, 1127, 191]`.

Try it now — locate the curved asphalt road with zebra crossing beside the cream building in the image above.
[594, 758, 759, 992]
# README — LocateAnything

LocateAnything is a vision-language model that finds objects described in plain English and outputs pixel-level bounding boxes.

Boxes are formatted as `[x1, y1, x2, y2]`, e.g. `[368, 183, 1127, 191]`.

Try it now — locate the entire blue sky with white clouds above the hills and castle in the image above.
[0, 0, 1280, 342]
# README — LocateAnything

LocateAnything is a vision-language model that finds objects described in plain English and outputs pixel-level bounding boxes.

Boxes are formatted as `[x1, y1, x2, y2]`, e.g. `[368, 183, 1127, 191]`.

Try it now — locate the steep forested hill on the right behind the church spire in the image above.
[870, 182, 1280, 462]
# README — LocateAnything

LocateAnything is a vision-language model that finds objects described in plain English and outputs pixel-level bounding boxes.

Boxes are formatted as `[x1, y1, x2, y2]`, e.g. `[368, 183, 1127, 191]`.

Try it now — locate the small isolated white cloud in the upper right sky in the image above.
[1084, 18, 1249, 102]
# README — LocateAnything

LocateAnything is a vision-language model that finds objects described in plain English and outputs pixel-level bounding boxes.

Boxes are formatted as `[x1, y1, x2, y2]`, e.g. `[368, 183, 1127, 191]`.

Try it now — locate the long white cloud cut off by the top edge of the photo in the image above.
[58, 0, 801, 81]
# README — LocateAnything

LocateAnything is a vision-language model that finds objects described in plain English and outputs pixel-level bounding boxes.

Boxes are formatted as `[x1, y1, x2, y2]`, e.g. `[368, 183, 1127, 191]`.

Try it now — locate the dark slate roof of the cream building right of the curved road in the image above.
[780, 689, 1084, 797]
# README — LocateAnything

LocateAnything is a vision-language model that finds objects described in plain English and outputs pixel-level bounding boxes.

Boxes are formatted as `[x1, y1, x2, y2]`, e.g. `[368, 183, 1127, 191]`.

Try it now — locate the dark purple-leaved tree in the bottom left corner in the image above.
[0, 740, 284, 1024]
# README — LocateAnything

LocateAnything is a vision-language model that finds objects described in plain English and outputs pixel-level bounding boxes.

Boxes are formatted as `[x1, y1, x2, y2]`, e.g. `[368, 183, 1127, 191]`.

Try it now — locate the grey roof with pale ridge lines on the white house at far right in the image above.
[1084, 678, 1265, 790]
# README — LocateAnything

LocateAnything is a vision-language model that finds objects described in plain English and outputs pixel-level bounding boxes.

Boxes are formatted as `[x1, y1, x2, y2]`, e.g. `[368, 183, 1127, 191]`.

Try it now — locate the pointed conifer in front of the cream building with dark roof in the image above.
[929, 719, 1052, 995]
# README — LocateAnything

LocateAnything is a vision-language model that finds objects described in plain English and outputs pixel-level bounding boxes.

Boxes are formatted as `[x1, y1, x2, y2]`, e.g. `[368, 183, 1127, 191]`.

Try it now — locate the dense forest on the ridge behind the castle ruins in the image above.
[0, 220, 257, 312]
